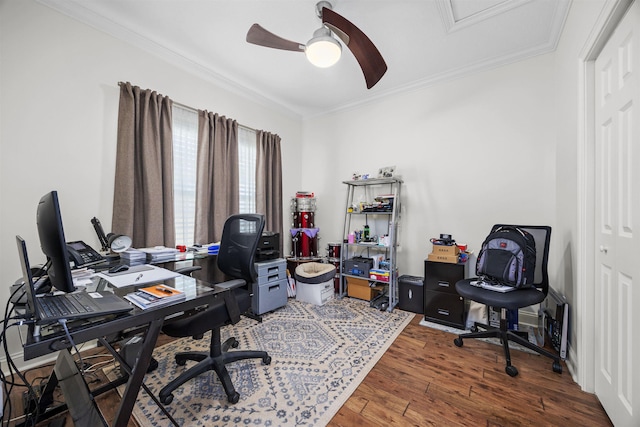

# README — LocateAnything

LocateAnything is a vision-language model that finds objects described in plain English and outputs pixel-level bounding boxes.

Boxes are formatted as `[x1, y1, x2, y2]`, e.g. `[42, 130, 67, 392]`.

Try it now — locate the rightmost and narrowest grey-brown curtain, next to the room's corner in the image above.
[256, 131, 283, 248]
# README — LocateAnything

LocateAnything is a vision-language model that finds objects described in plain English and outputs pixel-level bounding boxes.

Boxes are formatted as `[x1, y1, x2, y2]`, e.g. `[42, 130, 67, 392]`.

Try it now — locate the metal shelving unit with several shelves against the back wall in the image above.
[339, 178, 402, 311]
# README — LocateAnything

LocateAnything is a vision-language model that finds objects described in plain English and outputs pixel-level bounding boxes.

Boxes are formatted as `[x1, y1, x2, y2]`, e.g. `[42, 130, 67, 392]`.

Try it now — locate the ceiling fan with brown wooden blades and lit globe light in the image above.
[247, 1, 387, 89]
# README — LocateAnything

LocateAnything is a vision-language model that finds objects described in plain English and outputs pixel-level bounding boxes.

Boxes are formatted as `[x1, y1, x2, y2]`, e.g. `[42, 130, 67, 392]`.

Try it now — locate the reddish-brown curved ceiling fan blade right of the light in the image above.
[322, 7, 387, 89]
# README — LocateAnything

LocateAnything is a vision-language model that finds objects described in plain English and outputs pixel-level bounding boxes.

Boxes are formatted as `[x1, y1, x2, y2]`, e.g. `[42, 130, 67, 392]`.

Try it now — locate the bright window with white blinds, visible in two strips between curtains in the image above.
[172, 103, 256, 245]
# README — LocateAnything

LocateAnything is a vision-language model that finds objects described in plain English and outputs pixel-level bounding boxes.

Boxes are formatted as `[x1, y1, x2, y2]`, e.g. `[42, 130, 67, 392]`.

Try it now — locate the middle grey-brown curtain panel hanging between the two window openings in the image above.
[195, 110, 240, 244]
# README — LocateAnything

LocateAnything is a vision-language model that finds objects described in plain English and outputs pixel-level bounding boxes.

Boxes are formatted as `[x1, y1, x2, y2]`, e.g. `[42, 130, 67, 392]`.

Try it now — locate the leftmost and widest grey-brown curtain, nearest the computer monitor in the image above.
[111, 83, 175, 248]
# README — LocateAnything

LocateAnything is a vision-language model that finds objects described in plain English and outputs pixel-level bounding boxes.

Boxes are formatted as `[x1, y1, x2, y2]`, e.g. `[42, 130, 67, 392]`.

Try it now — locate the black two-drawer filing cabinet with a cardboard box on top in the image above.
[424, 260, 467, 329]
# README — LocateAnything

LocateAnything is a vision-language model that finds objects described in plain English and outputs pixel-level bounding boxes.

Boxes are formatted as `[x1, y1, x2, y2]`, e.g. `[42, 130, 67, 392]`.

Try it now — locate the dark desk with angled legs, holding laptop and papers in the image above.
[22, 276, 240, 427]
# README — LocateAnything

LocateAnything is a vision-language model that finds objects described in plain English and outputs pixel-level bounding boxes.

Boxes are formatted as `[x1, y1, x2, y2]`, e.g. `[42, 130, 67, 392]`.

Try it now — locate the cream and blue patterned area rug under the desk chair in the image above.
[111, 298, 414, 427]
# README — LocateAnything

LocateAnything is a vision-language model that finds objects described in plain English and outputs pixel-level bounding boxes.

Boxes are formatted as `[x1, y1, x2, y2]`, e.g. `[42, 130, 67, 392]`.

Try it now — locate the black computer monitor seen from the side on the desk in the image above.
[37, 191, 76, 292]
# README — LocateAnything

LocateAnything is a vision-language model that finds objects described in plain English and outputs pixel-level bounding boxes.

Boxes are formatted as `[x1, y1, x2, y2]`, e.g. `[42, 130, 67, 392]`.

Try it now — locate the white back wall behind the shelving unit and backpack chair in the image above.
[302, 55, 557, 276]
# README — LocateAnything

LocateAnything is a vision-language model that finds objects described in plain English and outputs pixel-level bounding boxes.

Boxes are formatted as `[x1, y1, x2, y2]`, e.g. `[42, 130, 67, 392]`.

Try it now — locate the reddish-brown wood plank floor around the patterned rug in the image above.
[12, 315, 612, 427]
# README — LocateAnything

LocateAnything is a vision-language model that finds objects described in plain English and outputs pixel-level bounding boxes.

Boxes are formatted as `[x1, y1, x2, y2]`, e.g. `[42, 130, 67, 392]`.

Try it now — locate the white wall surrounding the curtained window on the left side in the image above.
[0, 0, 302, 368]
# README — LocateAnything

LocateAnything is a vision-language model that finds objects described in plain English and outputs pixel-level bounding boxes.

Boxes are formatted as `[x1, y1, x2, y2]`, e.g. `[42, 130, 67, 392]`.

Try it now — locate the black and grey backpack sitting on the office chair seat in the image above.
[476, 226, 536, 288]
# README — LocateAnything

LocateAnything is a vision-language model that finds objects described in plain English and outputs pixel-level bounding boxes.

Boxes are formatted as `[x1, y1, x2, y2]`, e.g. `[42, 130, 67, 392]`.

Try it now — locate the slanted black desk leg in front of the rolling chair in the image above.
[113, 319, 164, 427]
